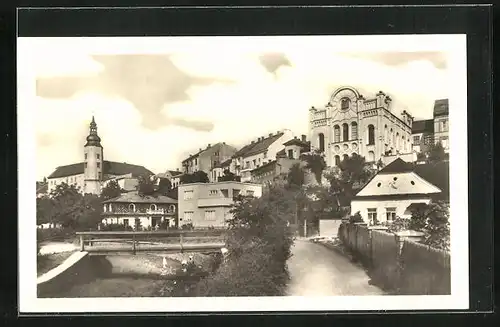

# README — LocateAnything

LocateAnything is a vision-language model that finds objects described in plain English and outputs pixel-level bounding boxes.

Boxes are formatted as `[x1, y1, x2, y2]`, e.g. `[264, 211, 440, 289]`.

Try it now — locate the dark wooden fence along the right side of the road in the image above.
[338, 223, 451, 295]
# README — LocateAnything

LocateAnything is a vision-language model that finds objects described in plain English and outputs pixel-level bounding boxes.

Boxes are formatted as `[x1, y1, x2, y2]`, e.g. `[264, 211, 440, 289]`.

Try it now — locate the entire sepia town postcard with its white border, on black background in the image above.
[17, 34, 469, 312]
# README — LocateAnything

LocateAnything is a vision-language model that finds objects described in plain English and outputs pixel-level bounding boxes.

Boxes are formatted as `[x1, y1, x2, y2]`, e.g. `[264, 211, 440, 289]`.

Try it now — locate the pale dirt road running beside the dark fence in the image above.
[288, 240, 384, 296]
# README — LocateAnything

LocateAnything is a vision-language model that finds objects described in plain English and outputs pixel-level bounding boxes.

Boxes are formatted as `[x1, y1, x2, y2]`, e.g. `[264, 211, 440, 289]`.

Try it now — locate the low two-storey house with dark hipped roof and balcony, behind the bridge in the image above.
[102, 191, 177, 229]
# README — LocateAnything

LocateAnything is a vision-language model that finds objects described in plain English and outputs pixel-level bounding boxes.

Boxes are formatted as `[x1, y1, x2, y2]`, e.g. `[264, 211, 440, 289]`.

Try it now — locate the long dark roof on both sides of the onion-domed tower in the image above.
[47, 160, 153, 178]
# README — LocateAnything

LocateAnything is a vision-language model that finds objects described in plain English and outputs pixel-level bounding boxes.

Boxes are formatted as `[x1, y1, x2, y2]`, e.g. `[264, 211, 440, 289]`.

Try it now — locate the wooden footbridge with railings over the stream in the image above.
[76, 230, 226, 255]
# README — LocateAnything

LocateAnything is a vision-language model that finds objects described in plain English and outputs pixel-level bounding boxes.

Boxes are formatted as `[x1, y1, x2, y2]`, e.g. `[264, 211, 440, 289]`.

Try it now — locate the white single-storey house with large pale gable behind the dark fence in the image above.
[351, 158, 449, 224]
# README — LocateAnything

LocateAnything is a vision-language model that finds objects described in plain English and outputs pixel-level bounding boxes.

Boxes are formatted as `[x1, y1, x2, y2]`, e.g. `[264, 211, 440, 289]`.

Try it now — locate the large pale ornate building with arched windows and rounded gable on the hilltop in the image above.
[309, 86, 413, 166]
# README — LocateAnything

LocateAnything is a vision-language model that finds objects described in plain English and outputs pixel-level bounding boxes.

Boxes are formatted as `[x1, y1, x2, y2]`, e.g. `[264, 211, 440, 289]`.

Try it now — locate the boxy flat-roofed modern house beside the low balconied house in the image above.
[179, 181, 262, 228]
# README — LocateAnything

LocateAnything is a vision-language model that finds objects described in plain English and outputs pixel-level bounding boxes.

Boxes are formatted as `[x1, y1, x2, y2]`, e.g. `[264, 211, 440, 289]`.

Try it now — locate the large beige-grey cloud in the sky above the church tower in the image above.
[37, 55, 232, 131]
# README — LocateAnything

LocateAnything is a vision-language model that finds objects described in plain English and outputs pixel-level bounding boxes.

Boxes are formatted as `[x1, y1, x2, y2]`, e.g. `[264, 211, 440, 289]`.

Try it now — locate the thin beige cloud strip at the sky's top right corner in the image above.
[344, 51, 446, 69]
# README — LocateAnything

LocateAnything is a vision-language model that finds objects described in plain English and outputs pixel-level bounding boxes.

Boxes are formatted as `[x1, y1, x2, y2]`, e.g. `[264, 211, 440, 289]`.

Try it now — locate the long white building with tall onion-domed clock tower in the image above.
[47, 117, 153, 195]
